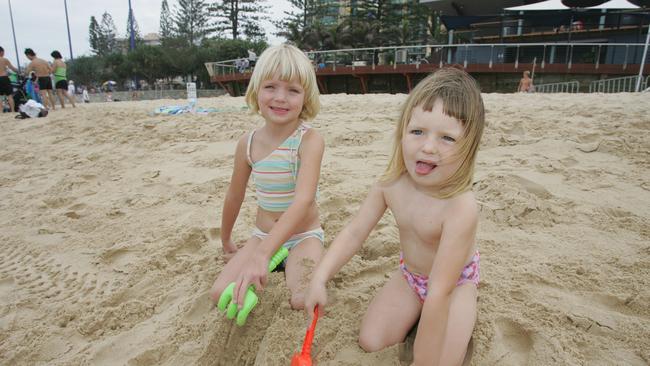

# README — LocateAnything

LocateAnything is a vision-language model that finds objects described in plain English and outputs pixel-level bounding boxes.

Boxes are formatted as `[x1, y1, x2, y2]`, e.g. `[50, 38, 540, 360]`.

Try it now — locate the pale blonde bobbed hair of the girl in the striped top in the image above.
[246, 44, 320, 120]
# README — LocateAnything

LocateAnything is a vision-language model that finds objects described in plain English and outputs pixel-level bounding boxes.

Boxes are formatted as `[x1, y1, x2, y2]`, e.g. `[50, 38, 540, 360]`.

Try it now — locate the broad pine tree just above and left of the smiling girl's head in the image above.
[210, 0, 268, 40]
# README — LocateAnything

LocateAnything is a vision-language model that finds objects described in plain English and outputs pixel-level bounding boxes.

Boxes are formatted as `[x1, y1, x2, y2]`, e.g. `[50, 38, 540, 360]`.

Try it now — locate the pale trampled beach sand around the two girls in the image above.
[0, 94, 650, 365]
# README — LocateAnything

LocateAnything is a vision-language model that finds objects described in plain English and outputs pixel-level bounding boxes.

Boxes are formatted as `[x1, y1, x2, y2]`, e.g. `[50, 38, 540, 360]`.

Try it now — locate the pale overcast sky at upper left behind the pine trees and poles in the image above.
[0, 0, 290, 67]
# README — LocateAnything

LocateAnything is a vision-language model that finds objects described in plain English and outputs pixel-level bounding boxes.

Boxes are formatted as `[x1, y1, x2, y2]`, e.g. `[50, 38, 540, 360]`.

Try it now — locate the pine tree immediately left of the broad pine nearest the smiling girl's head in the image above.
[173, 0, 210, 46]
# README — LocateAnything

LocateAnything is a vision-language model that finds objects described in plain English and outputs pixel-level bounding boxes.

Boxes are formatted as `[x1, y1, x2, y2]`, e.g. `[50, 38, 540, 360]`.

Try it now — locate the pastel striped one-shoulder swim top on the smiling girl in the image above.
[246, 124, 310, 212]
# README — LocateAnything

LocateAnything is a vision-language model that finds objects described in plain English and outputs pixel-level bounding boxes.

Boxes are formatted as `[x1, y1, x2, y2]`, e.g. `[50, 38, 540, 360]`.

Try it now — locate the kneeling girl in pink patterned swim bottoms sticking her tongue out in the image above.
[305, 68, 485, 365]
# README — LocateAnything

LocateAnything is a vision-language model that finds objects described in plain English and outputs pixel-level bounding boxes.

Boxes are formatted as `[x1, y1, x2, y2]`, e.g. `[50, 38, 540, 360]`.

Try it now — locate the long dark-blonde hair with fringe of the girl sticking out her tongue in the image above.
[381, 67, 485, 198]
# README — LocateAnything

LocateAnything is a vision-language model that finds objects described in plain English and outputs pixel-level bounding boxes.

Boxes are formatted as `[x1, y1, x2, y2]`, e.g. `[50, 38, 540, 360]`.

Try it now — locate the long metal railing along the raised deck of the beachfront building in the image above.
[205, 42, 644, 77]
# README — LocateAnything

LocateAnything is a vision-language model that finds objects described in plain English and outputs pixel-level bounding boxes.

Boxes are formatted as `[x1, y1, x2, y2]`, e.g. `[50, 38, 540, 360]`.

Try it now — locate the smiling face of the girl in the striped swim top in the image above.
[257, 75, 305, 124]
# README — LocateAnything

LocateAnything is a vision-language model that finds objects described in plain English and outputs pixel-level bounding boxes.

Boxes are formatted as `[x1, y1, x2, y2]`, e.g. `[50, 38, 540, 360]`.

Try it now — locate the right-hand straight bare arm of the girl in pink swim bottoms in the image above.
[413, 199, 478, 365]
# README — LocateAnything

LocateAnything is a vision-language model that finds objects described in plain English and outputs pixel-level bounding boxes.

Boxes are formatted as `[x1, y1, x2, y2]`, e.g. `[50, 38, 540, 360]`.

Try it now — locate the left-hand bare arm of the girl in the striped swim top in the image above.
[221, 134, 251, 253]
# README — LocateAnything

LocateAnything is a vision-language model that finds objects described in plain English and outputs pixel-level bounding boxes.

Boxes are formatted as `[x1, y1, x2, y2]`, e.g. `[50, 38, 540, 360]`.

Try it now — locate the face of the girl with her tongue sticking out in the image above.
[402, 99, 464, 189]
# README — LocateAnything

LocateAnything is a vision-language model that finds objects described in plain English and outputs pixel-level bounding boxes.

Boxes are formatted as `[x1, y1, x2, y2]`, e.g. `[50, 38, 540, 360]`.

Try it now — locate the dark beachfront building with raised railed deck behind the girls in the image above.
[206, 0, 650, 94]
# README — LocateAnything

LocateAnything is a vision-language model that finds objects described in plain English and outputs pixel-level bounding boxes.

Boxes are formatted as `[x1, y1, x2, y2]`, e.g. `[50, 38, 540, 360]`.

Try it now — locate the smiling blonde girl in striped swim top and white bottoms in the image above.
[210, 45, 325, 309]
